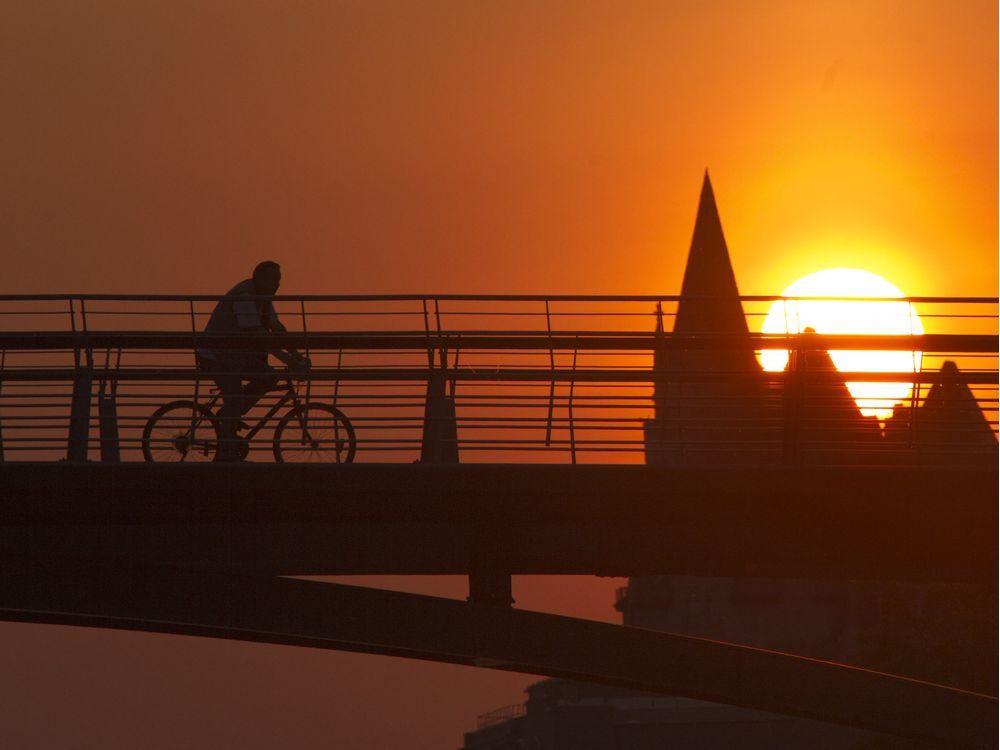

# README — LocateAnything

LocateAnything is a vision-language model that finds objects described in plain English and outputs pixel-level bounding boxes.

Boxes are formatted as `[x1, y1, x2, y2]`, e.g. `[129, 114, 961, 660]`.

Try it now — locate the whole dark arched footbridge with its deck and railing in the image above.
[0, 295, 998, 747]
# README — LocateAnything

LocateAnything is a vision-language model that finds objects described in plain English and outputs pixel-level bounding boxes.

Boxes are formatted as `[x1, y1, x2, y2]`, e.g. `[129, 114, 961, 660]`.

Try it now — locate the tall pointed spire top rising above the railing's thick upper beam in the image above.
[674, 170, 748, 334]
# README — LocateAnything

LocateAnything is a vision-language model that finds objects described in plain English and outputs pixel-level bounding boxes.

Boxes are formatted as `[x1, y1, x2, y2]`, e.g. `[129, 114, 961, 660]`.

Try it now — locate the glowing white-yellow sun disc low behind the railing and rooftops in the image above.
[760, 268, 924, 420]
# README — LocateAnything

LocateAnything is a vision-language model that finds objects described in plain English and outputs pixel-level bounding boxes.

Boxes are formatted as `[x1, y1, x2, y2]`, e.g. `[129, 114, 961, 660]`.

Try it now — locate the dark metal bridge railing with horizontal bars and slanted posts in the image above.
[0, 295, 997, 464]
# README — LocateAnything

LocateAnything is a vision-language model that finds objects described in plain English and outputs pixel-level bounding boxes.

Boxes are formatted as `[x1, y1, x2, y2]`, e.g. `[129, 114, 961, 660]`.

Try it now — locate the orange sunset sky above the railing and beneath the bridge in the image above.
[0, 0, 998, 750]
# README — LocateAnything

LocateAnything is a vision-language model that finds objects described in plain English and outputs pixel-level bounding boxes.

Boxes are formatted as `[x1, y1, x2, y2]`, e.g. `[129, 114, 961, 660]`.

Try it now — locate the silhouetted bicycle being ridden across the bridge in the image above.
[142, 378, 357, 463]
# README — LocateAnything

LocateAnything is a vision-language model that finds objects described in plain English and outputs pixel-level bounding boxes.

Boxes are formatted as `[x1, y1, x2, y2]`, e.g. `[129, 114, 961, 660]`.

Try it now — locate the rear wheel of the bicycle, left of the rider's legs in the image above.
[142, 401, 219, 463]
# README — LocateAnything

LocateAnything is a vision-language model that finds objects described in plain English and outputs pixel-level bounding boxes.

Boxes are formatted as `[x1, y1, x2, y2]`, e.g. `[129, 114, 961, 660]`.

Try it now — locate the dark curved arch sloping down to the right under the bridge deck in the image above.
[0, 560, 997, 747]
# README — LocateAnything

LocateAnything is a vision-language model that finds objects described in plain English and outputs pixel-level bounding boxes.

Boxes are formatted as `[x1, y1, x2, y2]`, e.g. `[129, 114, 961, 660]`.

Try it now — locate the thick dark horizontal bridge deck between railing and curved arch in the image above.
[0, 463, 997, 581]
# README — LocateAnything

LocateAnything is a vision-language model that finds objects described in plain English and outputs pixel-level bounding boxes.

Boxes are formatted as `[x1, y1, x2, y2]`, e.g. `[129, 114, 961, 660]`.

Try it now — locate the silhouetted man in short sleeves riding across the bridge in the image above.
[196, 260, 312, 461]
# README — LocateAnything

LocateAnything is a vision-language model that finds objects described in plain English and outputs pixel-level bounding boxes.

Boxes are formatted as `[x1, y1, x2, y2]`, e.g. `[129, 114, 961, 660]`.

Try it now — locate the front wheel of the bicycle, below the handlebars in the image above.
[274, 403, 358, 464]
